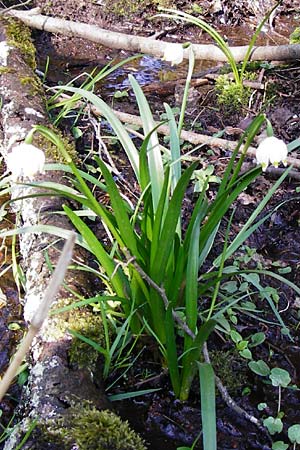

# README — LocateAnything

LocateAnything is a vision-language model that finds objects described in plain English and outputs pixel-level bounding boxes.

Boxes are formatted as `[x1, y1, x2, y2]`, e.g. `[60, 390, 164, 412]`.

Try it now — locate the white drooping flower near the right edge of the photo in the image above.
[256, 136, 288, 171]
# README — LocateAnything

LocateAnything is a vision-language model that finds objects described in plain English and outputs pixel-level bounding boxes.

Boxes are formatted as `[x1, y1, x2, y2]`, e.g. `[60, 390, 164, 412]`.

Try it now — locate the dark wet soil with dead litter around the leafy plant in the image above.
[0, 0, 300, 450]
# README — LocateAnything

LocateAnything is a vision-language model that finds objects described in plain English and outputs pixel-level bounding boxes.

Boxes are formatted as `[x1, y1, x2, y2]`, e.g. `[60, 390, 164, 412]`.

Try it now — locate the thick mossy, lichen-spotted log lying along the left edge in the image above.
[0, 18, 145, 450]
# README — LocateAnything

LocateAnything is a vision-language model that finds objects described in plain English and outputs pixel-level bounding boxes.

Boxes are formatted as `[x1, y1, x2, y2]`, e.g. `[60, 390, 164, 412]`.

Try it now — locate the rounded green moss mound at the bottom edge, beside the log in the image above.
[44, 402, 146, 450]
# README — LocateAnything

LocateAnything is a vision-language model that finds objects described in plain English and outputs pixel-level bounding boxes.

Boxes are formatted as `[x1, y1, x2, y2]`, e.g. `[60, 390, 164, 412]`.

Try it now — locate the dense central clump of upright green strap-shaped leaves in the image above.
[26, 108, 264, 399]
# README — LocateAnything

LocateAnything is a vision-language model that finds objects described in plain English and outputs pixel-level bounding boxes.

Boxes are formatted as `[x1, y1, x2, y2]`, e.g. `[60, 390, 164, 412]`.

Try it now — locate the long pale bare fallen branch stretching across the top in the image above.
[4, 10, 300, 61]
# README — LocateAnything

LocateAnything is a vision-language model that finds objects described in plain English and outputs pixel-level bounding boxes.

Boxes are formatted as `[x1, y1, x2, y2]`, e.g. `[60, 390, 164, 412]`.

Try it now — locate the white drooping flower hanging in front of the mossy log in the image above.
[7, 143, 45, 180]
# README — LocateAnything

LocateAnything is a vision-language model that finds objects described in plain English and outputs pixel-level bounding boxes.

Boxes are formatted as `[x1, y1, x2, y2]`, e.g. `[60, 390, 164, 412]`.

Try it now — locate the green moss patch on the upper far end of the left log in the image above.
[5, 18, 36, 70]
